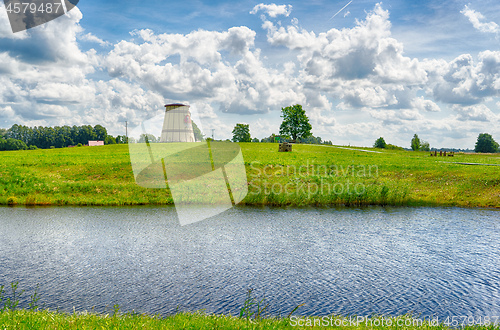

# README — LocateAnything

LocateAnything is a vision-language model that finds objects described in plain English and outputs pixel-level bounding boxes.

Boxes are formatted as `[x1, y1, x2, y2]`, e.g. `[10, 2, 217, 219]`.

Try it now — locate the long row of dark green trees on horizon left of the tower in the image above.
[0, 124, 127, 150]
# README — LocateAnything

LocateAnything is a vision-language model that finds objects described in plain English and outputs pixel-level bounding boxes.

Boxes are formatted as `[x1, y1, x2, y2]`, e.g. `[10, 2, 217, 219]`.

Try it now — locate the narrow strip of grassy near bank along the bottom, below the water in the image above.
[0, 310, 500, 330]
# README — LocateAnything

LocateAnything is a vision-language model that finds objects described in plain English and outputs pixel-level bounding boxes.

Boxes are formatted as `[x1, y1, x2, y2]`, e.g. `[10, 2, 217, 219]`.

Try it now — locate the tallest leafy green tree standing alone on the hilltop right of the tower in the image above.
[280, 104, 312, 140]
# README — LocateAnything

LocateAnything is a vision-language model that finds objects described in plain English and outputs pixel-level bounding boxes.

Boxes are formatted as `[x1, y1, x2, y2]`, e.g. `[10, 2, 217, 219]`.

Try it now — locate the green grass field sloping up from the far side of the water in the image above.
[0, 143, 500, 207]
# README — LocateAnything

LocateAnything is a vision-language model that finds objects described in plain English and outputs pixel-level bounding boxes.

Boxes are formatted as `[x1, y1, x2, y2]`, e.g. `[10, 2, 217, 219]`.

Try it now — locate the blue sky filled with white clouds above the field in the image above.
[0, 0, 500, 149]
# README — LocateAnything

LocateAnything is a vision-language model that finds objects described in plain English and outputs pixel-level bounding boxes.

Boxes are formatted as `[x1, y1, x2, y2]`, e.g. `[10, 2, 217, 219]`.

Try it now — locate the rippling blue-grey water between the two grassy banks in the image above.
[0, 207, 500, 316]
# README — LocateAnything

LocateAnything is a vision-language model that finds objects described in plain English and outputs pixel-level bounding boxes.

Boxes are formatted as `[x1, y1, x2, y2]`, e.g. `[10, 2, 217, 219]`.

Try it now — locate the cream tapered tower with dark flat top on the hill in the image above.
[160, 104, 195, 142]
